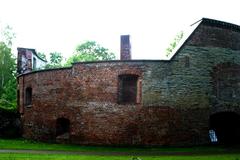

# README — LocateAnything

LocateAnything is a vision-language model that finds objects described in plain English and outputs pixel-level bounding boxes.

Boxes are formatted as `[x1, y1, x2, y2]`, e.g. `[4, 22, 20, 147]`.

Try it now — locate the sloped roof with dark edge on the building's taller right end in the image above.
[166, 18, 240, 60]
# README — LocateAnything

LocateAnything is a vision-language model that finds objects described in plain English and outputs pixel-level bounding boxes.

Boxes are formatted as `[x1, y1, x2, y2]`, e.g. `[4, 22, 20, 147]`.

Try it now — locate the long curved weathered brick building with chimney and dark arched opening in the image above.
[18, 18, 240, 145]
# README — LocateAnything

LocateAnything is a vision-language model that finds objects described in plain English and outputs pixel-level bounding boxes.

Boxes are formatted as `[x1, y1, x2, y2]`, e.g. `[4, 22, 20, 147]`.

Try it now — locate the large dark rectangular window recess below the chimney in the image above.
[118, 75, 138, 104]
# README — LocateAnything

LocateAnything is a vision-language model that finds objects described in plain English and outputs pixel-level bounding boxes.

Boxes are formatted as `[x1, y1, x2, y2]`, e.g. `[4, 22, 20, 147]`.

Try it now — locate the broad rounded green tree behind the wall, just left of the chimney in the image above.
[66, 41, 116, 65]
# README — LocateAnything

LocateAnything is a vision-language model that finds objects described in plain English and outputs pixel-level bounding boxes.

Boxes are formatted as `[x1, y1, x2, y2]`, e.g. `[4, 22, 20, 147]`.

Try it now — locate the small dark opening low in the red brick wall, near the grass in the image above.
[56, 118, 70, 136]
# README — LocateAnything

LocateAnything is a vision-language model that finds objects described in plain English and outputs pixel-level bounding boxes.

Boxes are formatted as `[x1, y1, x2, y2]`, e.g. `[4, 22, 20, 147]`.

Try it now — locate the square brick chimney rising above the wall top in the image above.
[120, 35, 132, 60]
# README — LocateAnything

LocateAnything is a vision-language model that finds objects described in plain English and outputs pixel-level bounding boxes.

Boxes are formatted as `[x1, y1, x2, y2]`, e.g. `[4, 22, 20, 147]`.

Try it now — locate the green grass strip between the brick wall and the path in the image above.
[0, 139, 236, 153]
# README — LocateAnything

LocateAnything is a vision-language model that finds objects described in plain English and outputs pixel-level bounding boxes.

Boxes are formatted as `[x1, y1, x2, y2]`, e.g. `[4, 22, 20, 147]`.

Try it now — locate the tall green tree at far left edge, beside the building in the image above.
[0, 26, 16, 108]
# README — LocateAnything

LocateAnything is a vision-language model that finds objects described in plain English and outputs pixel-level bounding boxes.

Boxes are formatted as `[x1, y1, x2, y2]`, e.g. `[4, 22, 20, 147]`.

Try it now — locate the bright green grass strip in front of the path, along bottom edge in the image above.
[0, 153, 240, 160]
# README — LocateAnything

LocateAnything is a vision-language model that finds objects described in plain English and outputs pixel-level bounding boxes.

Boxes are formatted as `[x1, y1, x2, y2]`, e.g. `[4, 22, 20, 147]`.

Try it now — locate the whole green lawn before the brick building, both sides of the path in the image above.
[0, 139, 240, 160]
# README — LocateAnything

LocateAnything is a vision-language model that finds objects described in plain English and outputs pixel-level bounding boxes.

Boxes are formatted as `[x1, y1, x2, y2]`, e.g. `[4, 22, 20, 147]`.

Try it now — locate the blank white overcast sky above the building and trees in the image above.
[0, 0, 240, 59]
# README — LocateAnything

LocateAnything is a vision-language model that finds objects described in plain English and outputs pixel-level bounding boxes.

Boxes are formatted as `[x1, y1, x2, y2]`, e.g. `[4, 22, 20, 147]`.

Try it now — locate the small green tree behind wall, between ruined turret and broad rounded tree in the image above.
[45, 52, 63, 68]
